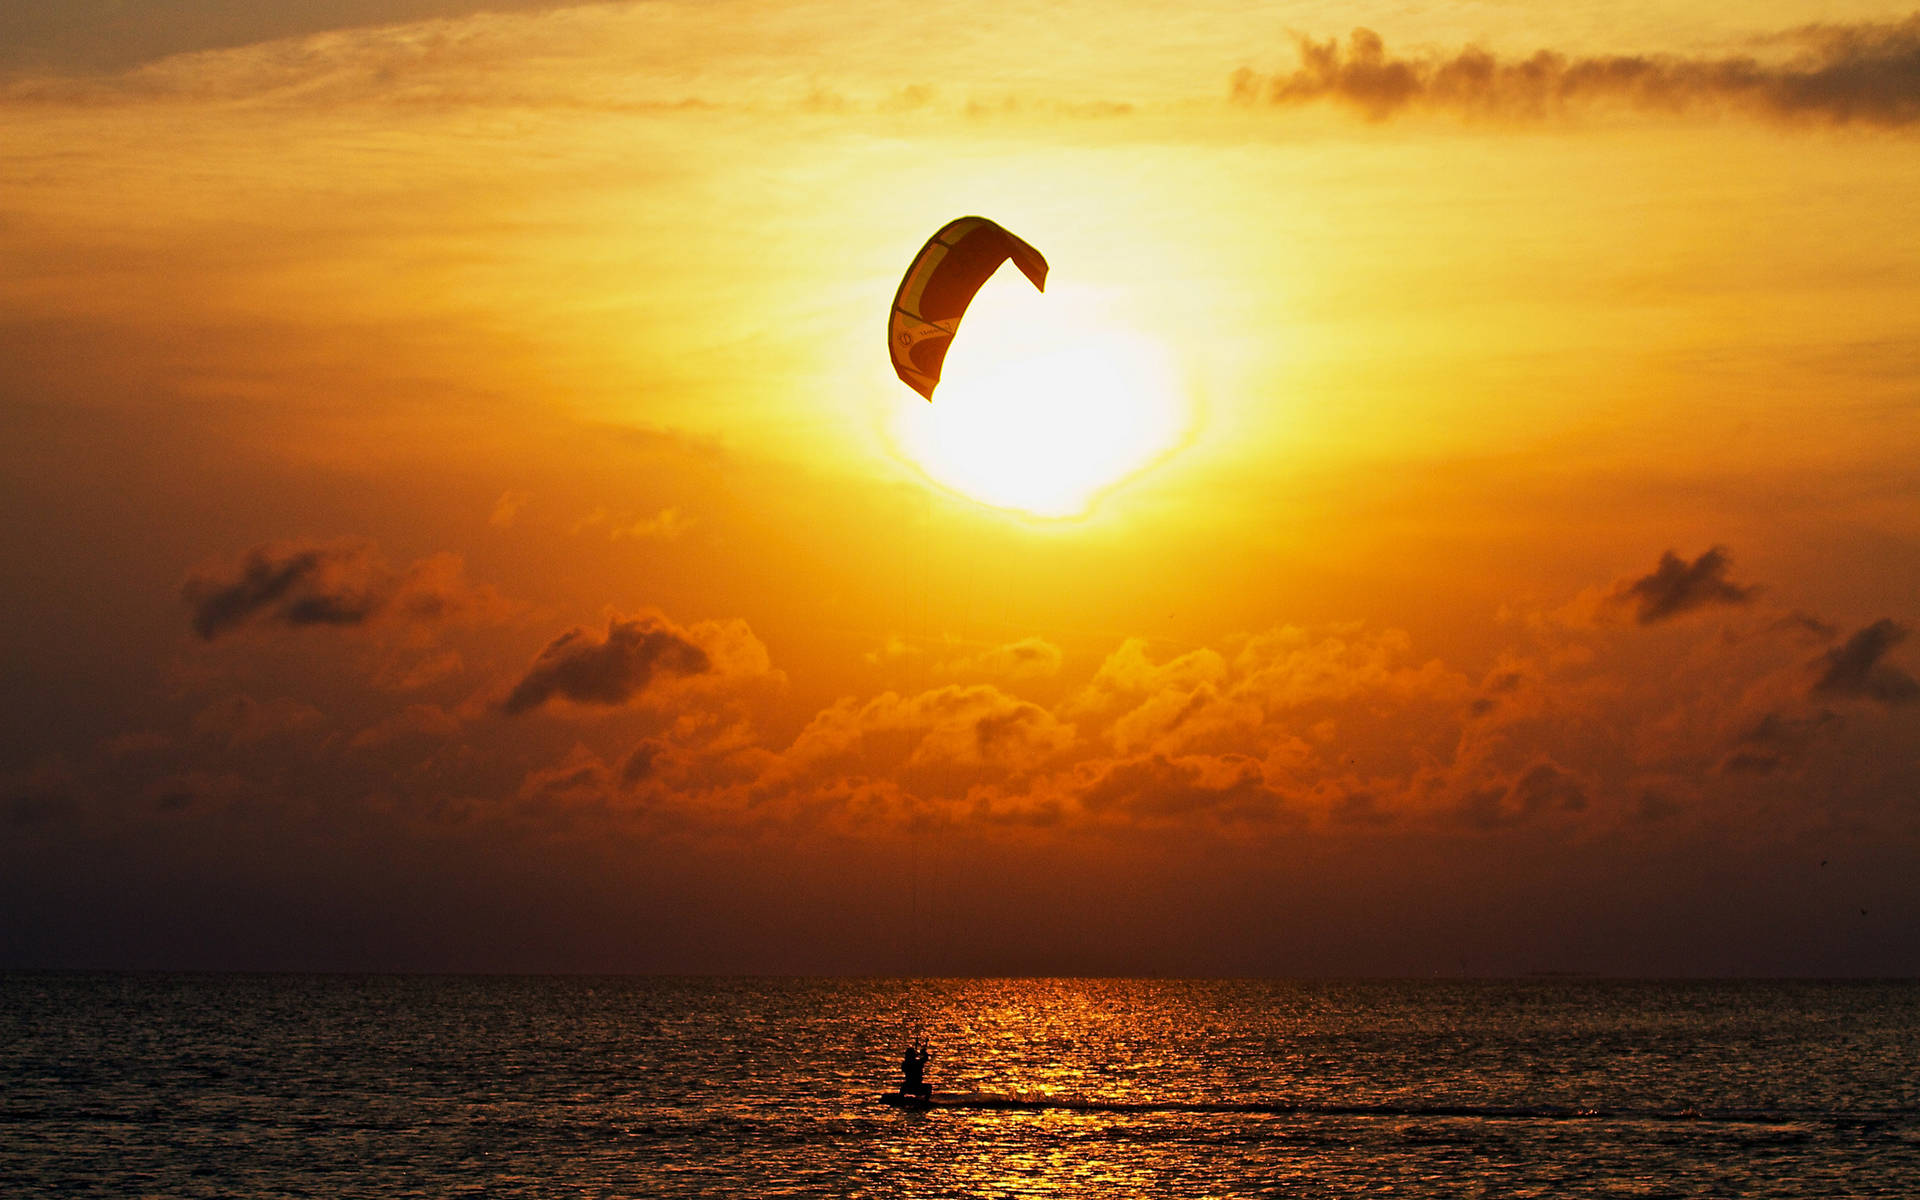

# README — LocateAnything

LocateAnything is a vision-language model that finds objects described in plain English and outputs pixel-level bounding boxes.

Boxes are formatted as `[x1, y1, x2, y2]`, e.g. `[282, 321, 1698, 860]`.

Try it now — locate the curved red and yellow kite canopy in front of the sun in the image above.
[887, 217, 1046, 399]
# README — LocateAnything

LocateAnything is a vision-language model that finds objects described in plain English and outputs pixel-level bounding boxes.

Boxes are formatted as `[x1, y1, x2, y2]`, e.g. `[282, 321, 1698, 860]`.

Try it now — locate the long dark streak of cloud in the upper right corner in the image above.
[1231, 13, 1920, 129]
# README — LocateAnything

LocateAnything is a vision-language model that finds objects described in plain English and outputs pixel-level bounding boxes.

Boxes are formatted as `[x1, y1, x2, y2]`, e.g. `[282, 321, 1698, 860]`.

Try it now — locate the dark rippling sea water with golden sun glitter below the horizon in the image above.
[0, 973, 1920, 1198]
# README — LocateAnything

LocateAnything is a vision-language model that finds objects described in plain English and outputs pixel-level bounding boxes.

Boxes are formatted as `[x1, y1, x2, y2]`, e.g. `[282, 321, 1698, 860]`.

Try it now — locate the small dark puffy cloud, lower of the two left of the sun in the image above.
[503, 614, 714, 714]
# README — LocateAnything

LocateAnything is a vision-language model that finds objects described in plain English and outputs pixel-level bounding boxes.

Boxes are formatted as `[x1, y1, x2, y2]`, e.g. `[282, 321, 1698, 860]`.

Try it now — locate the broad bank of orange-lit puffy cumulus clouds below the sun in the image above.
[149, 547, 1920, 852]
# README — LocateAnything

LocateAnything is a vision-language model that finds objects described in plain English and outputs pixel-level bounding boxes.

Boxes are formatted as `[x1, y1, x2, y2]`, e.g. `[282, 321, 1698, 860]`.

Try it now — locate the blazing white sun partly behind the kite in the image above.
[893, 276, 1192, 518]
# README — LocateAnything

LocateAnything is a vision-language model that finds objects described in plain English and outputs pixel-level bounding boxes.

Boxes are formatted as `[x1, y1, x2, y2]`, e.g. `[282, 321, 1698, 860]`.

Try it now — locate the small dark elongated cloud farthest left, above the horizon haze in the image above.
[180, 540, 499, 641]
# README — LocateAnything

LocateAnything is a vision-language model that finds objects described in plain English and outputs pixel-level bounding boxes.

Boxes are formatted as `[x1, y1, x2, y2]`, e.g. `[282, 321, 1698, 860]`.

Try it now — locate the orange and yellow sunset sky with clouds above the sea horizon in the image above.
[0, 0, 1920, 975]
